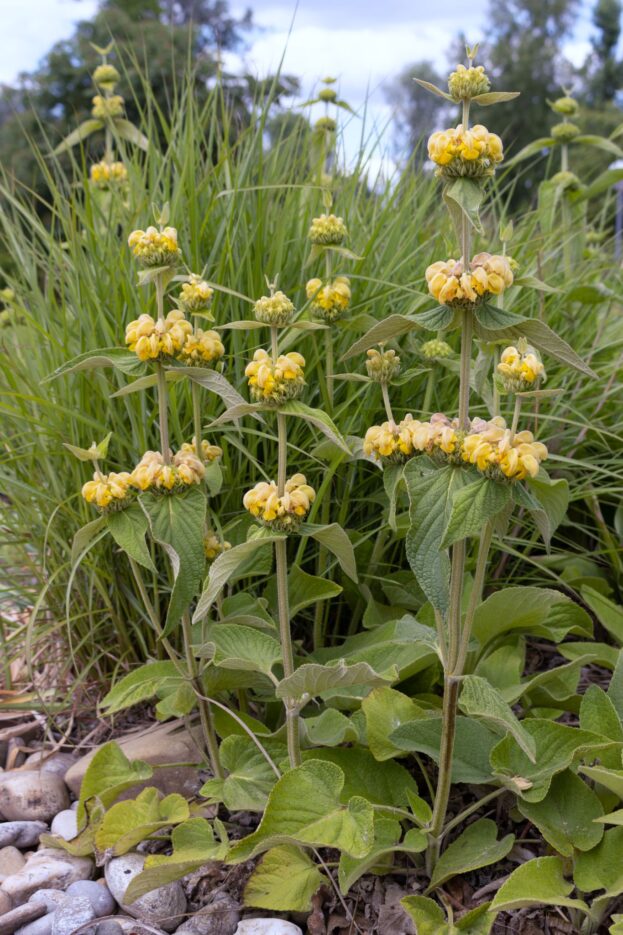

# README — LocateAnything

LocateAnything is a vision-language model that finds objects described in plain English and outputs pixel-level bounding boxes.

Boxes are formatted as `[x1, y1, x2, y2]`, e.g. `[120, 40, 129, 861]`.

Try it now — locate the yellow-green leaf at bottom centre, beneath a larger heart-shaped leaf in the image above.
[244, 844, 329, 912]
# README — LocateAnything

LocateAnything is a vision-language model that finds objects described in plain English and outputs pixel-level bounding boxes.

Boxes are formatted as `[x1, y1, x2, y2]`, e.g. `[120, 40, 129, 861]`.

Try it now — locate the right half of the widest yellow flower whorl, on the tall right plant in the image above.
[462, 418, 548, 481]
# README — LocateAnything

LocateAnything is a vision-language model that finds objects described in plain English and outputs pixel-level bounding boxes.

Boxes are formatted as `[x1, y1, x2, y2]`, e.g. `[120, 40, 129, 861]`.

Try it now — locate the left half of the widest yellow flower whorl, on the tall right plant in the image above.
[363, 412, 460, 462]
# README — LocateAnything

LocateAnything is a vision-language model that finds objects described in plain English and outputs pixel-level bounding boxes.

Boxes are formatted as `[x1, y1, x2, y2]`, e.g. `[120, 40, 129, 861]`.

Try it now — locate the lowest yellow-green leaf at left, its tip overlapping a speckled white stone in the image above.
[123, 818, 227, 904]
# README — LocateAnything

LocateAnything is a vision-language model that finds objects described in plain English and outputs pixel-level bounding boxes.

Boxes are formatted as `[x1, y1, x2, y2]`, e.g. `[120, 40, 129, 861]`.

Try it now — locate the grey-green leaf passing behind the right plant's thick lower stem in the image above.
[389, 716, 498, 783]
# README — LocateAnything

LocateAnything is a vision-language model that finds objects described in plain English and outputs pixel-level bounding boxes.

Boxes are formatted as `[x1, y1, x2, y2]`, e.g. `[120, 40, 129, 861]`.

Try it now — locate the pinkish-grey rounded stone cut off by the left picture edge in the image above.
[0, 769, 69, 821]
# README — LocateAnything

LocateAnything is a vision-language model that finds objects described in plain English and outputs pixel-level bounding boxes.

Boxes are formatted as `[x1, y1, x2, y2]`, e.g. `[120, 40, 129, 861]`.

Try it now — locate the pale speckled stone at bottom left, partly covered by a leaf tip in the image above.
[106, 852, 187, 932]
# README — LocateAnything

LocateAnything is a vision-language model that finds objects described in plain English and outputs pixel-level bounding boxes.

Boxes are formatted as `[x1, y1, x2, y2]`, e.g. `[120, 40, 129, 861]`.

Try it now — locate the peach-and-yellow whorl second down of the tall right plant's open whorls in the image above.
[425, 253, 513, 308]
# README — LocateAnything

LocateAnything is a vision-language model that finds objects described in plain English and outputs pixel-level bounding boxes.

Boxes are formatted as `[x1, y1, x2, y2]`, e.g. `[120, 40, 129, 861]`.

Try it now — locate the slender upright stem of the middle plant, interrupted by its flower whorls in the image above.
[270, 327, 301, 768]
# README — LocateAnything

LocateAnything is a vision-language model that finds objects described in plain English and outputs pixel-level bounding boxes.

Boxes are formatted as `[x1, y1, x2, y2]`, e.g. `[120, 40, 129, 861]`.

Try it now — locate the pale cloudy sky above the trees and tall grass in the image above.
[0, 0, 608, 174]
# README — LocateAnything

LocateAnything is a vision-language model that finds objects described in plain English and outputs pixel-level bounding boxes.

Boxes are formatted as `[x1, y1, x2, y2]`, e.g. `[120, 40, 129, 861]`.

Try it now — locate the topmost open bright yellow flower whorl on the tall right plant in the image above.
[428, 123, 504, 178]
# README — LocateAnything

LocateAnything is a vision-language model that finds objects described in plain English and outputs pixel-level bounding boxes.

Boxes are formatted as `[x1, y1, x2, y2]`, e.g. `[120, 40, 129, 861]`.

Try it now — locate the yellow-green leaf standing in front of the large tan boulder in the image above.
[78, 740, 153, 828]
